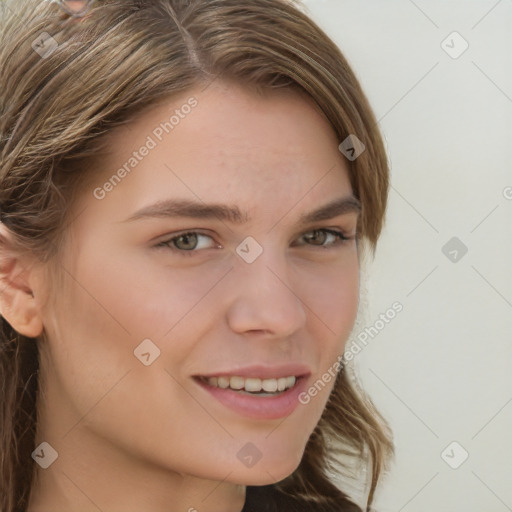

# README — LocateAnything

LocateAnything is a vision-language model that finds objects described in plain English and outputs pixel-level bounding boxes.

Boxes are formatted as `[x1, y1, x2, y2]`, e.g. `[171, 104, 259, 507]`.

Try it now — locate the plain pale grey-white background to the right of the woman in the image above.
[304, 0, 512, 512]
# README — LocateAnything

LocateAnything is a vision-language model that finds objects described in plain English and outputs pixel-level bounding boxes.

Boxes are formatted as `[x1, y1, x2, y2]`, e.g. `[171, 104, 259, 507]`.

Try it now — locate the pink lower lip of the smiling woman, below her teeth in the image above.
[194, 376, 307, 420]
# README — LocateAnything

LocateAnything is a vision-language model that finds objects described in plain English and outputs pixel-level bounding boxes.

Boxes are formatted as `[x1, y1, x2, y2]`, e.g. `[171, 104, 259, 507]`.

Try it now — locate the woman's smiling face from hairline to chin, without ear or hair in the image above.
[33, 81, 359, 500]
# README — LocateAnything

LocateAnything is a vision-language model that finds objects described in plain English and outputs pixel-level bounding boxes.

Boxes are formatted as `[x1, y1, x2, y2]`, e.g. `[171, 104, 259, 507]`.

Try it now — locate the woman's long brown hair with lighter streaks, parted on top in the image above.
[0, 0, 392, 512]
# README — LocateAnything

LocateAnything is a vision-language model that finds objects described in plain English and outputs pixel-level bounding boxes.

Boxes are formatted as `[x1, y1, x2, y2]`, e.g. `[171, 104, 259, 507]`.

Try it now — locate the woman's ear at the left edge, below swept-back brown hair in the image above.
[0, 222, 43, 338]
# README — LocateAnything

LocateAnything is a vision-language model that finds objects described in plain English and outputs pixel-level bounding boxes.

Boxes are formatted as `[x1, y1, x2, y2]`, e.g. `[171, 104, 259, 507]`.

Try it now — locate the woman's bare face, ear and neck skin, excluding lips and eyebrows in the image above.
[0, 81, 359, 512]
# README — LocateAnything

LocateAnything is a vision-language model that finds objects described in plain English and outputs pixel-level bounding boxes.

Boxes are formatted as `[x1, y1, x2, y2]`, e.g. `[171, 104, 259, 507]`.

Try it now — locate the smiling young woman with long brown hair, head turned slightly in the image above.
[0, 0, 392, 512]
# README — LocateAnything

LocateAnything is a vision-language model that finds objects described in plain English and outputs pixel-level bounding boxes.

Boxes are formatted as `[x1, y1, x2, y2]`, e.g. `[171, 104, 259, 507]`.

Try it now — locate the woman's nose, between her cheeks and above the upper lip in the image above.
[227, 249, 306, 338]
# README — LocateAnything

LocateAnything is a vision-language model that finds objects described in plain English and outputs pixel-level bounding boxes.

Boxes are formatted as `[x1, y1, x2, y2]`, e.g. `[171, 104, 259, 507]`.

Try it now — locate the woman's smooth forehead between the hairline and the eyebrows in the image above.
[72, 81, 351, 224]
